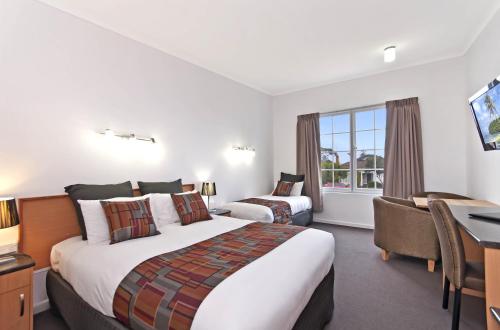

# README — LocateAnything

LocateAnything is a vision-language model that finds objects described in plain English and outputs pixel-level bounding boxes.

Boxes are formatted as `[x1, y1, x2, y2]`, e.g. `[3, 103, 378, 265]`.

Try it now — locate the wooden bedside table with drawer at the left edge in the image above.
[0, 253, 35, 330]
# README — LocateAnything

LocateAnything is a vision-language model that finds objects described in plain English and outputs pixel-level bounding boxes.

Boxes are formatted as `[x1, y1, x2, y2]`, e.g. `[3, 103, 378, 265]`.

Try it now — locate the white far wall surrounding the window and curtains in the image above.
[273, 58, 470, 227]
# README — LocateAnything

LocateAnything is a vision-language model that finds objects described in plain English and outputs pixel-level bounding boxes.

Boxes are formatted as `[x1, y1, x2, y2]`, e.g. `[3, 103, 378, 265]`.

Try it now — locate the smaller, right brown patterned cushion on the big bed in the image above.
[170, 192, 212, 226]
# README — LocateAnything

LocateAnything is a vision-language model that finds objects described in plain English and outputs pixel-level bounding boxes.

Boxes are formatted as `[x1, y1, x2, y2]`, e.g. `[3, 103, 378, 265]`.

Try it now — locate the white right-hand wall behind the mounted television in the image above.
[466, 11, 500, 203]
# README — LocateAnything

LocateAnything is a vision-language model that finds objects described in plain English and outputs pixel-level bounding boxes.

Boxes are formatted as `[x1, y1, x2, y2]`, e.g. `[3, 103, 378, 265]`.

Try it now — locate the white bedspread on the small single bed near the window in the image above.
[223, 195, 312, 222]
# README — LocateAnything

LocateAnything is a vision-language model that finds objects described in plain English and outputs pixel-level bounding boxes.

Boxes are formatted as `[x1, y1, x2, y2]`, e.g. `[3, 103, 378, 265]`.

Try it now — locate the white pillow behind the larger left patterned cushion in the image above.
[78, 195, 154, 245]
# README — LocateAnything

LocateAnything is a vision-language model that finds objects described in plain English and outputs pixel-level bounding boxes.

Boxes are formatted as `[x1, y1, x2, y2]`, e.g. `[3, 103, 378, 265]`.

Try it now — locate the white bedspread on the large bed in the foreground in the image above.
[51, 216, 335, 330]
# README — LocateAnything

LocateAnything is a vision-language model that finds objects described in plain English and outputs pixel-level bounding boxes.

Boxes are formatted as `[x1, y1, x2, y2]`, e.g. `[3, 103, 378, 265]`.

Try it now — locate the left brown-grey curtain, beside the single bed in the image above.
[297, 113, 323, 212]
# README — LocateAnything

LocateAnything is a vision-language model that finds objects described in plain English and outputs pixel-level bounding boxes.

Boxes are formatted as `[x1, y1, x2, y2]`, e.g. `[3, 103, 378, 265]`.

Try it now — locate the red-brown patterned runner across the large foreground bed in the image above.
[113, 222, 305, 330]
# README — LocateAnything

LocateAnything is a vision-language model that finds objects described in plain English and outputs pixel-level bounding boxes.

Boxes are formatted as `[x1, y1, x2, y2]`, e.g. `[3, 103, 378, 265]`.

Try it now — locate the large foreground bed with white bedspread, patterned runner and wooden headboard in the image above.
[20, 185, 335, 329]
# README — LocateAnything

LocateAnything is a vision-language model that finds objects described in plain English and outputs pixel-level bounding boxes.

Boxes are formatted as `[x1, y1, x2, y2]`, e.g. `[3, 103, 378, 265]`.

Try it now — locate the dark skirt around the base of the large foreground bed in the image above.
[47, 265, 335, 330]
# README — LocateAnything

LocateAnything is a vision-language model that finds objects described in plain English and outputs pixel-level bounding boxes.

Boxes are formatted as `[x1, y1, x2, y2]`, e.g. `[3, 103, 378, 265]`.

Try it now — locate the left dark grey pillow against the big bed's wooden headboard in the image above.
[64, 181, 134, 240]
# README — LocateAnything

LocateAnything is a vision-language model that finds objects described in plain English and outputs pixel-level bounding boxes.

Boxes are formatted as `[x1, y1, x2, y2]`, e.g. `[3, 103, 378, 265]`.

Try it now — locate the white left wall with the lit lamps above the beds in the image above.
[0, 0, 273, 311]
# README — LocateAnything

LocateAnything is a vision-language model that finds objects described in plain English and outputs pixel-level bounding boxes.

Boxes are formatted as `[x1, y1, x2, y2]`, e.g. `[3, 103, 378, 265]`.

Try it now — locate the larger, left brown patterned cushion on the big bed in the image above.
[101, 198, 160, 244]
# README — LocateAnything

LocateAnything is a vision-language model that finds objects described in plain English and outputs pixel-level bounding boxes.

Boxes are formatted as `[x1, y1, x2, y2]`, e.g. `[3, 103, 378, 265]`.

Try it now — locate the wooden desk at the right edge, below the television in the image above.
[449, 201, 500, 330]
